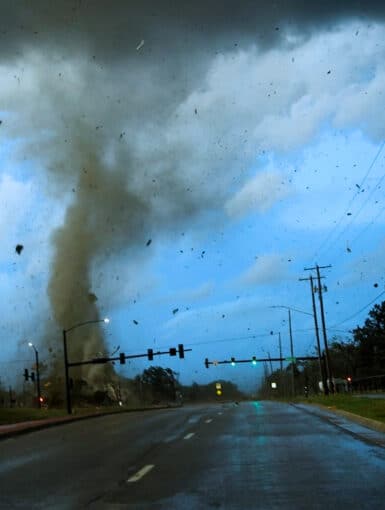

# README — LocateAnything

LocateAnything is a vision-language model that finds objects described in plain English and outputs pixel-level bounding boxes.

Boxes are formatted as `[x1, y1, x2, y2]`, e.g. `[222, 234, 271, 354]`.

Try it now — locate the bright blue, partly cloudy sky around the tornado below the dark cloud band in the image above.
[0, 15, 385, 388]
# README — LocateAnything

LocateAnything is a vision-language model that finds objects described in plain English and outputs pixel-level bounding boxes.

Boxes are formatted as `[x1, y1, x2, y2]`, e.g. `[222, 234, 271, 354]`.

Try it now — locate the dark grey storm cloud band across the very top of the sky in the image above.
[0, 0, 385, 59]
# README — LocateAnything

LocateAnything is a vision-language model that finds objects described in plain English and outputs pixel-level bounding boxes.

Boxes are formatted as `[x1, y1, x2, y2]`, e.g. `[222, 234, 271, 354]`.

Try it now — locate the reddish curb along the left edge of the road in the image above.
[0, 406, 176, 441]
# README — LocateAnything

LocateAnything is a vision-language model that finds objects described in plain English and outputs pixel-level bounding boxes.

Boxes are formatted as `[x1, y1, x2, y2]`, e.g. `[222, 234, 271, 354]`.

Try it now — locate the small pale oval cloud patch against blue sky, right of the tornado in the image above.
[225, 172, 289, 218]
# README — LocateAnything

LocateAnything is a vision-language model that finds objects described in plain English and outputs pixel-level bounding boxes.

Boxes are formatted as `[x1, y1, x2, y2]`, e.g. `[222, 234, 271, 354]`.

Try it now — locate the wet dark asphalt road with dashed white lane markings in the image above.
[0, 402, 385, 510]
